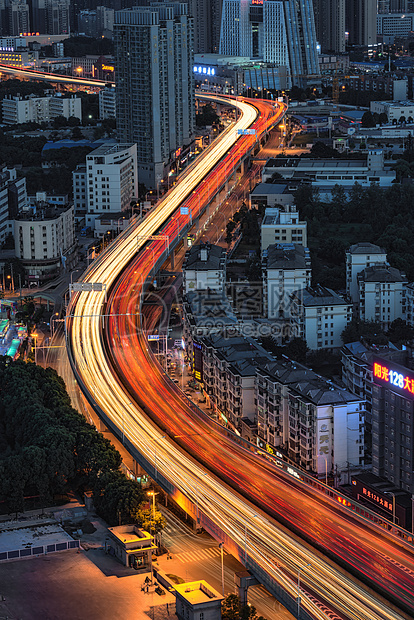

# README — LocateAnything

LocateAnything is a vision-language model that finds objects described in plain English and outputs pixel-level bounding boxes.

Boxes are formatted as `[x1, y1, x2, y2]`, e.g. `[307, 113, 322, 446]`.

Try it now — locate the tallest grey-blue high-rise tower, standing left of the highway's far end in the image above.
[114, 2, 195, 187]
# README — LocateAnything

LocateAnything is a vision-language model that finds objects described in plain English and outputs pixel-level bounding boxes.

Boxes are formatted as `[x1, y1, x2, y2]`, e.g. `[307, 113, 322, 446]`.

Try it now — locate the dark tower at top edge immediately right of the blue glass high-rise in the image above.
[313, 0, 345, 53]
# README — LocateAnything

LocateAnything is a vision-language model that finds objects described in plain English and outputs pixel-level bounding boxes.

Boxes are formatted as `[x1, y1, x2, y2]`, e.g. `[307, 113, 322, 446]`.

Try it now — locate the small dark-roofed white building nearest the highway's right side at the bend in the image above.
[183, 243, 226, 293]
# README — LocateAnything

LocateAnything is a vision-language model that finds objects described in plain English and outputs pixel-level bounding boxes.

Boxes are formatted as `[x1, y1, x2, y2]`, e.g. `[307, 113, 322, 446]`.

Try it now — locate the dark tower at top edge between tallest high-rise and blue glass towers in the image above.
[188, 0, 223, 54]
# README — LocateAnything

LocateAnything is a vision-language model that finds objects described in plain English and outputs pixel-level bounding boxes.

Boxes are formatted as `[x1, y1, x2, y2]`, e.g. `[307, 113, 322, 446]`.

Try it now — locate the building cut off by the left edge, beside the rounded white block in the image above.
[0, 165, 27, 244]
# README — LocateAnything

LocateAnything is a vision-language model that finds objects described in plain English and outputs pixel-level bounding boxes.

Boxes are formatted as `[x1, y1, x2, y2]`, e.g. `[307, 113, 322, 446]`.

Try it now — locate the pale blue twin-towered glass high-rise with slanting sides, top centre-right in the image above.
[220, 0, 319, 80]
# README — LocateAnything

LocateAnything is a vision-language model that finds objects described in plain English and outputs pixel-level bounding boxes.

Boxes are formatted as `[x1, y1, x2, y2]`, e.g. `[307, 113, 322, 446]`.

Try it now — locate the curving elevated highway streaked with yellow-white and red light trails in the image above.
[66, 97, 414, 620]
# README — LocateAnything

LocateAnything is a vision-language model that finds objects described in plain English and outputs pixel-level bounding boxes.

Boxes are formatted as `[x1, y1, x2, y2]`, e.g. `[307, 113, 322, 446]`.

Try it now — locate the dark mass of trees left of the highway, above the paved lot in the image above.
[0, 357, 150, 525]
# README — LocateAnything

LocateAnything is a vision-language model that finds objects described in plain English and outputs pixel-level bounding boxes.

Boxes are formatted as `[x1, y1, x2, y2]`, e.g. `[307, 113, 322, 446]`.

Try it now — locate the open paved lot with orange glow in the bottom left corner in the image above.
[0, 549, 175, 620]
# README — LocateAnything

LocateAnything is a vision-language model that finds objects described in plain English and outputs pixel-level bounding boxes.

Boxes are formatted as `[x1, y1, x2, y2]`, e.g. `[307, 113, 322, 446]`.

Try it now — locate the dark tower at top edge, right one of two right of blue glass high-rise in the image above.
[345, 0, 377, 46]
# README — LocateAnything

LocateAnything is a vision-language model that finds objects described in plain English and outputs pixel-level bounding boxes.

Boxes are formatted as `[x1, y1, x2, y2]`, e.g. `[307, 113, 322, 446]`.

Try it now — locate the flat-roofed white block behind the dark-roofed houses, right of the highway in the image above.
[261, 207, 308, 252]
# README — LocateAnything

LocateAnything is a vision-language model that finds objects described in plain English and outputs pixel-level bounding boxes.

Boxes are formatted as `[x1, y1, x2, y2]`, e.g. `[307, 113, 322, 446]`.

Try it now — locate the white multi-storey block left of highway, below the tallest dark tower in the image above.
[73, 143, 138, 228]
